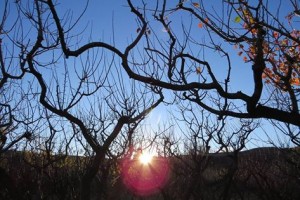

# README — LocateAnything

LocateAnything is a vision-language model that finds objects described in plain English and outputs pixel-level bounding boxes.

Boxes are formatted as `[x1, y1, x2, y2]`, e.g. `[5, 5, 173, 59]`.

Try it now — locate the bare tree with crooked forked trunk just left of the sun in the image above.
[1, 0, 164, 199]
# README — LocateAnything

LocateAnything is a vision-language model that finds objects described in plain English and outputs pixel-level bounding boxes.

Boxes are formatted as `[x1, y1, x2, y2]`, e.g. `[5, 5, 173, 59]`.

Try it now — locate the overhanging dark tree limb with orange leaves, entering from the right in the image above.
[111, 0, 300, 126]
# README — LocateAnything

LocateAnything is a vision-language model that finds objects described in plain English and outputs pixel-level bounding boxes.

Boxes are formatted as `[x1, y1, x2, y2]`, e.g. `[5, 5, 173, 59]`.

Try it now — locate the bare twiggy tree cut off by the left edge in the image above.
[0, 1, 39, 154]
